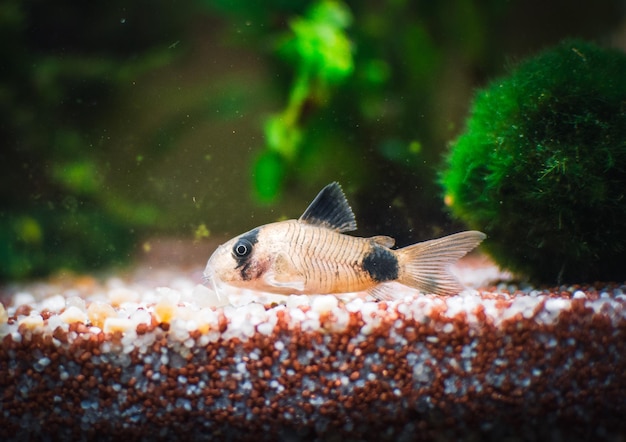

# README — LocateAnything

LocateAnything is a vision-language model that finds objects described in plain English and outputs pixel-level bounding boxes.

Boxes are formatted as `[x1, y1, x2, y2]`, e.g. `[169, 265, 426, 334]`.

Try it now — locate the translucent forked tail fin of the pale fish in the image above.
[396, 230, 487, 295]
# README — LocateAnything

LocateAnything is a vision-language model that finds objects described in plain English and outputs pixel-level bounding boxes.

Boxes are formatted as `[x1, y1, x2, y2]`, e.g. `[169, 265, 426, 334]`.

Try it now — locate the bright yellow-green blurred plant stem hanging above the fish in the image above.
[254, 0, 354, 201]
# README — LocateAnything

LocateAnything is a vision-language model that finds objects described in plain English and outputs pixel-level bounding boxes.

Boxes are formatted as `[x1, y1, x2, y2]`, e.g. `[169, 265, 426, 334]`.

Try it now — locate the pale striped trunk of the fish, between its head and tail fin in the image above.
[234, 220, 398, 294]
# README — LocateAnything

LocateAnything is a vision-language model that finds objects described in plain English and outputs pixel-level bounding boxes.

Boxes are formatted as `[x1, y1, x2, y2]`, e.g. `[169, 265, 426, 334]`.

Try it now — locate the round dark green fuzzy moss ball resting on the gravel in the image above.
[441, 41, 626, 283]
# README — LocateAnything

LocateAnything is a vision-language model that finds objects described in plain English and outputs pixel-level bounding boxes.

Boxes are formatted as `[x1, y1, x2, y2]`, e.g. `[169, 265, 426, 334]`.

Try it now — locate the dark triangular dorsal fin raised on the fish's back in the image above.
[299, 182, 356, 232]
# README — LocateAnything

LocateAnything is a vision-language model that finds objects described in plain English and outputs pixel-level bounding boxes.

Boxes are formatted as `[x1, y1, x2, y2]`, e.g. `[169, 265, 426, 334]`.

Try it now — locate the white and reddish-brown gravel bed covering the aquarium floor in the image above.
[0, 261, 626, 441]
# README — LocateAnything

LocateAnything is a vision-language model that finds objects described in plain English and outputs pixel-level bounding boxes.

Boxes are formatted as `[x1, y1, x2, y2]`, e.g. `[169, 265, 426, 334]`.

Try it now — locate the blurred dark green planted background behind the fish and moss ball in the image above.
[0, 0, 620, 279]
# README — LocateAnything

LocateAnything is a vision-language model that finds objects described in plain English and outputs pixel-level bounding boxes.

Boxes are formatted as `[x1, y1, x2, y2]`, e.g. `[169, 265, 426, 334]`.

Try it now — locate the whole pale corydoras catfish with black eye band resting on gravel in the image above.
[203, 182, 486, 300]
